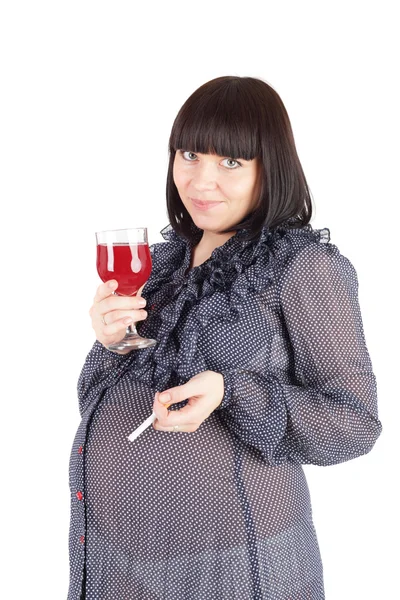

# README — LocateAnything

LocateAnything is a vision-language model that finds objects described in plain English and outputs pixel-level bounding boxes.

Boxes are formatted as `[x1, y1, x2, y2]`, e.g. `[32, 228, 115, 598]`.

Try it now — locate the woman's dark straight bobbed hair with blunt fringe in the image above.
[167, 76, 312, 240]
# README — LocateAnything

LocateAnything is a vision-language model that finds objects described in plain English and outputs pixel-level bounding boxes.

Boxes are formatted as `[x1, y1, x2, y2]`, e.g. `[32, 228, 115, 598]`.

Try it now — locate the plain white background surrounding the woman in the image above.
[0, 0, 400, 600]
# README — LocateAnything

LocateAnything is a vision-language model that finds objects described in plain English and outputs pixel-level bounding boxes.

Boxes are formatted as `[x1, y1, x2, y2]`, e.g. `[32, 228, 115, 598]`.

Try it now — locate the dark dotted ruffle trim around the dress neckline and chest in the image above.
[120, 225, 330, 391]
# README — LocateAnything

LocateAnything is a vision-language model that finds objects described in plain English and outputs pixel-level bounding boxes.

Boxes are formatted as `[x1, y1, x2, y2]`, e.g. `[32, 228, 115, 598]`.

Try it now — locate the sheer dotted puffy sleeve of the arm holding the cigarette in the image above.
[217, 244, 382, 465]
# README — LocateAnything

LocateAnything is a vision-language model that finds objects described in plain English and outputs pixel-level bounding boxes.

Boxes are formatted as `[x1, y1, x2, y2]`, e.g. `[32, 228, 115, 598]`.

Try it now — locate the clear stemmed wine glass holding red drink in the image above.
[96, 227, 157, 354]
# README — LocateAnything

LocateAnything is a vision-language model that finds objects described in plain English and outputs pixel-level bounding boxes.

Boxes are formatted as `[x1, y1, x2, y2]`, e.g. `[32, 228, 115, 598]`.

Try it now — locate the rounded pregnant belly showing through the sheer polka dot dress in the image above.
[85, 379, 310, 560]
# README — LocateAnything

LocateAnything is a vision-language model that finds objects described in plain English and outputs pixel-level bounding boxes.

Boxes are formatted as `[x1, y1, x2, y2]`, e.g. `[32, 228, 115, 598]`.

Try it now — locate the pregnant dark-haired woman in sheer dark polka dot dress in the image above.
[68, 76, 382, 600]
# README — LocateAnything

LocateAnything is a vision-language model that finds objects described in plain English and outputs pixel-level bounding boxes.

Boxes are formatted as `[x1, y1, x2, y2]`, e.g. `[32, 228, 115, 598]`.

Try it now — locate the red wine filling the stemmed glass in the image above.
[96, 243, 151, 296]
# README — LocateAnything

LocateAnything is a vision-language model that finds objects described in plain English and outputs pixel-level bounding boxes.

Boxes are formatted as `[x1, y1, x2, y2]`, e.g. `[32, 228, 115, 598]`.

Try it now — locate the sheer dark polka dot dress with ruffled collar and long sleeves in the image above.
[68, 225, 382, 600]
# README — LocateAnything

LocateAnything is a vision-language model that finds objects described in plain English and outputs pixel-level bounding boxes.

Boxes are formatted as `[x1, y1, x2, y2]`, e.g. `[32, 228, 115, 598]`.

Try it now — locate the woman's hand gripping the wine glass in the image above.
[89, 279, 147, 347]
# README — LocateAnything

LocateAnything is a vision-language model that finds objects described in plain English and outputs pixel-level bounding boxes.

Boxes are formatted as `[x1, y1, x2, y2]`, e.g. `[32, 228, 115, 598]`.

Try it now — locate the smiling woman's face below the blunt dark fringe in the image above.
[173, 150, 261, 233]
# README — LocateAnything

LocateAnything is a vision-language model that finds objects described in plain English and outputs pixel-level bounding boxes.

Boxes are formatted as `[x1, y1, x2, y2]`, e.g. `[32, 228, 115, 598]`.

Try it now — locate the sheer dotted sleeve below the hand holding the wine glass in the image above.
[77, 340, 130, 416]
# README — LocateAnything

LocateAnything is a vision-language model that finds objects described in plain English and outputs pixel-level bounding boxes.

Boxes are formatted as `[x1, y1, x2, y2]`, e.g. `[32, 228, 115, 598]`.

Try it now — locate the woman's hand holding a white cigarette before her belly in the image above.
[153, 371, 224, 432]
